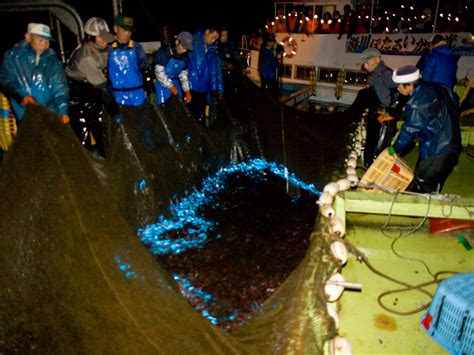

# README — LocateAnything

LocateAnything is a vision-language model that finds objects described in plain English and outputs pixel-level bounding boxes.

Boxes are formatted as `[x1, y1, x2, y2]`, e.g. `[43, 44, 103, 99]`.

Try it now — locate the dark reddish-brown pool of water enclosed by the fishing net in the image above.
[142, 170, 317, 331]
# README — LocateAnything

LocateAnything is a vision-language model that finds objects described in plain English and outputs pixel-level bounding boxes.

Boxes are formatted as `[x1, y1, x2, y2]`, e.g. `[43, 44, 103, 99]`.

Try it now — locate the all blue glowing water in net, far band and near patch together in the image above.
[136, 159, 321, 329]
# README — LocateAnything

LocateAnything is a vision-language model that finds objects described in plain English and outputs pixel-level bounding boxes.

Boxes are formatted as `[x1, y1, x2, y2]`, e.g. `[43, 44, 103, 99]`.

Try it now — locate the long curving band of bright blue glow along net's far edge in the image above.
[137, 159, 321, 255]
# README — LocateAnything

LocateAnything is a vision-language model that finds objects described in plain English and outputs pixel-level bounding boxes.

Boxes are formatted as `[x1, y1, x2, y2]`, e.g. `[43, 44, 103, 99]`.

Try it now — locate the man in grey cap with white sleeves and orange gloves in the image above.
[155, 32, 193, 105]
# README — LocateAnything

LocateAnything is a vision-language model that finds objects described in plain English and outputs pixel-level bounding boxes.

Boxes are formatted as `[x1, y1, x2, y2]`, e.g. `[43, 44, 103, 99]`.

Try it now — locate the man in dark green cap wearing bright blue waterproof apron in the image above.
[108, 15, 151, 106]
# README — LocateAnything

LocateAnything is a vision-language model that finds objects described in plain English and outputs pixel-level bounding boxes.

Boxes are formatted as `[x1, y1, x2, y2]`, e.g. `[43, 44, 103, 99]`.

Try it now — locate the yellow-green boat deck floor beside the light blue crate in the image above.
[338, 146, 474, 354]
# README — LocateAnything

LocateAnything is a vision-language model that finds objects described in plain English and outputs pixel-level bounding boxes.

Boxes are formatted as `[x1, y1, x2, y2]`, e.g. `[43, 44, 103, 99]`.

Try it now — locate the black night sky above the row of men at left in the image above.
[0, 0, 274, 58]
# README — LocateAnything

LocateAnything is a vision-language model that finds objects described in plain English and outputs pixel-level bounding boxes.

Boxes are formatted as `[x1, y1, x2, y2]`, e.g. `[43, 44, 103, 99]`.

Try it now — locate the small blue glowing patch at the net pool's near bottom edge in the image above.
[173, 274, 238, 325]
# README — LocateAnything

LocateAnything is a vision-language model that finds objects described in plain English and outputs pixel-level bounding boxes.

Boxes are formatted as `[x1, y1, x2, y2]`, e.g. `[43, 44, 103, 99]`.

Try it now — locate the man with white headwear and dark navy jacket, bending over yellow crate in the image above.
[393, 66, 461, 193]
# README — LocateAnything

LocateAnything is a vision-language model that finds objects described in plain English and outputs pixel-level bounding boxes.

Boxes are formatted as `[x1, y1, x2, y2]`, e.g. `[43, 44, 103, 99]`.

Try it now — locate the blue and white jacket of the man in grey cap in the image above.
[155, 46, 189, 104]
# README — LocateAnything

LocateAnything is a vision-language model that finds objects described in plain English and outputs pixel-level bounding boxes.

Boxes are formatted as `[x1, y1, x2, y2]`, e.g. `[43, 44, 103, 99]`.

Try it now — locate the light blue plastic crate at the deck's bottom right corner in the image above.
[421, 273, 474, 354]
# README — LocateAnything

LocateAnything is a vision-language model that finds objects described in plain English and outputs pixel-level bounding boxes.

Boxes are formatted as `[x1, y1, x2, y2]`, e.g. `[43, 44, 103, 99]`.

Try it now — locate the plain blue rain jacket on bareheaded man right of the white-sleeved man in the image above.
[188, 31, 224, 93]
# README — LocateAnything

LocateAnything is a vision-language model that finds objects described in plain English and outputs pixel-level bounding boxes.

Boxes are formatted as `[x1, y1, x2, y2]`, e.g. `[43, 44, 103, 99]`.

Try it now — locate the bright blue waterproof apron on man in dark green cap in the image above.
[108, 40, 148, 106]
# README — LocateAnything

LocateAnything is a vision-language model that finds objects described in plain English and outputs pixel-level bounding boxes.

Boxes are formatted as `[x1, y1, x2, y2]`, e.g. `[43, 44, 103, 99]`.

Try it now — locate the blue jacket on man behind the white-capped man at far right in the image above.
[421, 44, 458, 88]
